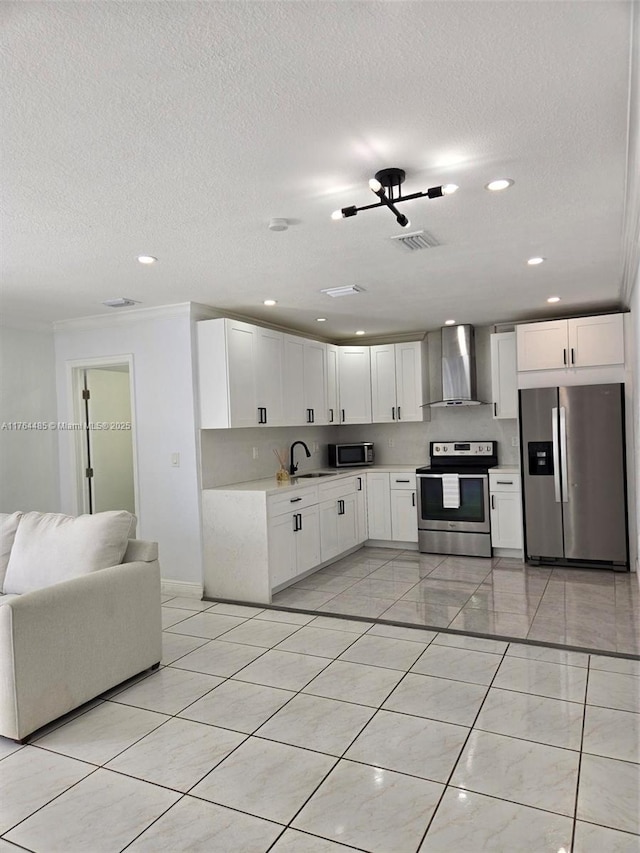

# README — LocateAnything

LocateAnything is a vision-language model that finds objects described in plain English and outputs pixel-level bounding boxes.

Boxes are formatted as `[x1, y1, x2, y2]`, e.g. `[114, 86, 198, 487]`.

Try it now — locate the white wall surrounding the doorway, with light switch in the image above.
[55, 305, 202, 585]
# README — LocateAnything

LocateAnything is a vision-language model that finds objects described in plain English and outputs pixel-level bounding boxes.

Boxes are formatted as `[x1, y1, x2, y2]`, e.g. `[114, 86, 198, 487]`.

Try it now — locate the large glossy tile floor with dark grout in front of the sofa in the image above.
[0, 604, 640, 853]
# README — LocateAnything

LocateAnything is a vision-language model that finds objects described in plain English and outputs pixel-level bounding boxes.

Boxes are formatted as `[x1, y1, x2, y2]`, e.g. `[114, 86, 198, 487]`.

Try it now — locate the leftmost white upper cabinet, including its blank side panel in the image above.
[198, 318, 284, 429]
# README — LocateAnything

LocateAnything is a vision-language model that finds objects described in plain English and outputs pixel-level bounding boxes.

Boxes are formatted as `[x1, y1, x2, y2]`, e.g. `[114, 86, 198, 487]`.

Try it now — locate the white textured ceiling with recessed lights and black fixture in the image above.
[0, 0, 631, 340]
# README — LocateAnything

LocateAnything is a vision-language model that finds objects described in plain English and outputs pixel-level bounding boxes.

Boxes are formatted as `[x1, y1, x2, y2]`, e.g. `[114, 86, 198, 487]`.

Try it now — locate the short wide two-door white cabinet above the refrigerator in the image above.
[516, 314, 624, 371]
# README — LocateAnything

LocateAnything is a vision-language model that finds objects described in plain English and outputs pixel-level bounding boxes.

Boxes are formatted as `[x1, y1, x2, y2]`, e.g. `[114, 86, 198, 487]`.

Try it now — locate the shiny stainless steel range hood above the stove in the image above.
[430, 325, 482, 407]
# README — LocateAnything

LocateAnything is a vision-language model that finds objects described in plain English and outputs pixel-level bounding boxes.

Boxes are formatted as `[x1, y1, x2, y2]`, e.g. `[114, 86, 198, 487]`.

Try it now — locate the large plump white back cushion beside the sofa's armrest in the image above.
[4, 511, 136, 593]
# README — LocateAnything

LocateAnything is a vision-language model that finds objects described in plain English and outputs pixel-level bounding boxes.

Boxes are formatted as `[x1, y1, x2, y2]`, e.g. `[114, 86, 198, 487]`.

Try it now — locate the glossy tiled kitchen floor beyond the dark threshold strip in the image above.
[273, 548, 640, 655]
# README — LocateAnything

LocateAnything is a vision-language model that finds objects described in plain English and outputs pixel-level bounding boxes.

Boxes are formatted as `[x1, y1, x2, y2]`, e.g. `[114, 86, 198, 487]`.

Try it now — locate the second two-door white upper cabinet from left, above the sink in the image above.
[284, 335, 328, 426]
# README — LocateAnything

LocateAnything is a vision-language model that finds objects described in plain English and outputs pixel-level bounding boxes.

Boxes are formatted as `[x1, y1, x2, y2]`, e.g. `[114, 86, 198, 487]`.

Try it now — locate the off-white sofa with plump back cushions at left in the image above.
[0, 512, 162, 741]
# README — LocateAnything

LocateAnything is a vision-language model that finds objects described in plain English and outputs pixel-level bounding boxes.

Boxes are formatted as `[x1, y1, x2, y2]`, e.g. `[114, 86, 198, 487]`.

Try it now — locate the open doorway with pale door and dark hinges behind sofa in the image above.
[72, 361, 138, 515]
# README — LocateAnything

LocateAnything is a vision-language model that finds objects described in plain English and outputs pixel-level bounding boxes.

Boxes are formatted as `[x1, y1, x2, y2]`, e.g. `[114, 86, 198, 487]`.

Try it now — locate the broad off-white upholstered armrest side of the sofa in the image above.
[0, 561, 162, 740]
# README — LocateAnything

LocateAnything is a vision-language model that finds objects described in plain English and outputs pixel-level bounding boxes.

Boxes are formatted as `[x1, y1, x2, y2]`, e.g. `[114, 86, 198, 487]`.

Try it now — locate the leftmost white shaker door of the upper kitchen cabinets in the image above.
[225, 320, 260, 427]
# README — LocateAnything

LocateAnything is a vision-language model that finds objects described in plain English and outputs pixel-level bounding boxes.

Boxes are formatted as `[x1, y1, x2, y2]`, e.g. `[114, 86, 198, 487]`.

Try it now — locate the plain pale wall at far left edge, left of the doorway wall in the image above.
[0, 326, 60, 512]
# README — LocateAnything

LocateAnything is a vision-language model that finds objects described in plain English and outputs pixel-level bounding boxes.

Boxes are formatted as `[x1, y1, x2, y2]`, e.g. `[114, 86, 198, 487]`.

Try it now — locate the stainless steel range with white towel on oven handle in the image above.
[416, 441, 498, 557]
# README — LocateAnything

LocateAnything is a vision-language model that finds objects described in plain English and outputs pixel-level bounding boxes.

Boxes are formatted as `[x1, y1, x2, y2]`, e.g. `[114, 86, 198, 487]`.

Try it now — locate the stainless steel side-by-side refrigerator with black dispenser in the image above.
[520, 384, 629, 571]
